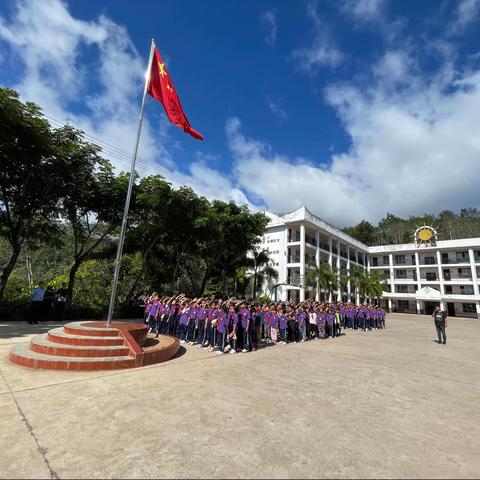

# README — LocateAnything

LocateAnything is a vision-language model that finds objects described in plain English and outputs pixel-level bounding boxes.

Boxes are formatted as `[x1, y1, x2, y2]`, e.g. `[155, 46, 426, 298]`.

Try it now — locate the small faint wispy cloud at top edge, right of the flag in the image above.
[292, 2, 343, 74]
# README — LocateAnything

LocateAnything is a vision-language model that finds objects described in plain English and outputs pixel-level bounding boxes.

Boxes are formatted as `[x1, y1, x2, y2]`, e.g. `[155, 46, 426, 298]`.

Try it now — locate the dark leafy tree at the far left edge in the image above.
[0, 88, 93, 299]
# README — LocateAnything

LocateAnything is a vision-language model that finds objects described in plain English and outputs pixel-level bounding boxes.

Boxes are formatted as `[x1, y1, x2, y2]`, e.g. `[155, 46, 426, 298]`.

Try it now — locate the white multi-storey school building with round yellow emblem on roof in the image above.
[259, 207, 480, 318]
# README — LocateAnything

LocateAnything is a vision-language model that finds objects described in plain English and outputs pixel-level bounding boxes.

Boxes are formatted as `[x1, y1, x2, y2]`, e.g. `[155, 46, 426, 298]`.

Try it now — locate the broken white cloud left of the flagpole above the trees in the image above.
[0, 0, 171, 169]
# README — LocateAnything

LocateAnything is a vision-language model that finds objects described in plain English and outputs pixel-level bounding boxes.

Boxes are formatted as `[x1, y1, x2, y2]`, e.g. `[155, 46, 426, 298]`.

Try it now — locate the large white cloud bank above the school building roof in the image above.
[227, 52, 480, 225]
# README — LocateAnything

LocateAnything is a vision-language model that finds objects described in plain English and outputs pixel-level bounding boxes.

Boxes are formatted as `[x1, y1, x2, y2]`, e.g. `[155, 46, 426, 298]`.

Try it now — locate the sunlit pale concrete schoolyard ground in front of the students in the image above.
[0, 314, 480, 478]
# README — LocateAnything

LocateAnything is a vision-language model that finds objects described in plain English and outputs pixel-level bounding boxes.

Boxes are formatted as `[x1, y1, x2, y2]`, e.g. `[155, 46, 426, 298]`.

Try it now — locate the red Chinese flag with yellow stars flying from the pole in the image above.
[147, 46, 203, 140]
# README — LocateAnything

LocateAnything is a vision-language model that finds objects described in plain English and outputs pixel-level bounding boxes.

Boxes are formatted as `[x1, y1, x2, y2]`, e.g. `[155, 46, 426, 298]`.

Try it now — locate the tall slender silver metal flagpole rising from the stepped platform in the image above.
[107, 39, 155, 327]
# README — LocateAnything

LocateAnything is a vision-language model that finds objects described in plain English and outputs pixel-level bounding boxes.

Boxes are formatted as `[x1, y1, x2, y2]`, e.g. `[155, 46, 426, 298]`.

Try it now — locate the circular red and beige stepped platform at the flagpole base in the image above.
[10, 322, 180, 370]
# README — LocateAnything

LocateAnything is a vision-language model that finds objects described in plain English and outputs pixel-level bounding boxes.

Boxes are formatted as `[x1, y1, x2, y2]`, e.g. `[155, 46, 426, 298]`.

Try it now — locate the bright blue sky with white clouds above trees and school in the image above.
[0, 0, 480, 225]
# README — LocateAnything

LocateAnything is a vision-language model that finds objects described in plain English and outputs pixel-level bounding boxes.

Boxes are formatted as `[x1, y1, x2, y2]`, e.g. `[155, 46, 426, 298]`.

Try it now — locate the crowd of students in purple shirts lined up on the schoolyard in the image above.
[140, 293, 385, 353]
